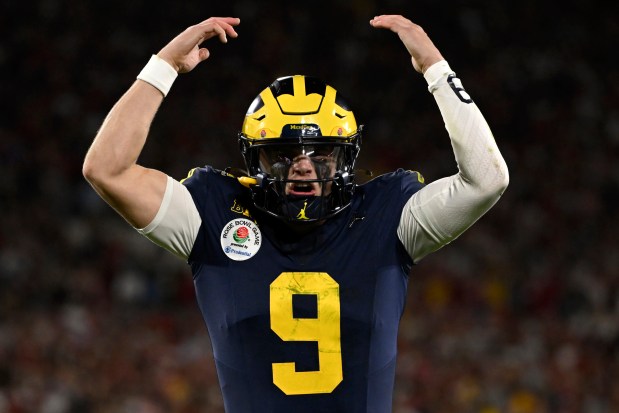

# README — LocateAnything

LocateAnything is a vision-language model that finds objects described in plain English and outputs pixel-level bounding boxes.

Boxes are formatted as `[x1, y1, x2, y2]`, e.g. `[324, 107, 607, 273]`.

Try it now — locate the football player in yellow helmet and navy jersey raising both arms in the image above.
[83, 15, 508, 413]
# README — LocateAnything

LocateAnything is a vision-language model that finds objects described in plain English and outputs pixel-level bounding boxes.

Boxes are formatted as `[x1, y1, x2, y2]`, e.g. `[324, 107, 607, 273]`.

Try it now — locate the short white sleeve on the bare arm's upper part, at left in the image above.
[136, 176, 202, 259]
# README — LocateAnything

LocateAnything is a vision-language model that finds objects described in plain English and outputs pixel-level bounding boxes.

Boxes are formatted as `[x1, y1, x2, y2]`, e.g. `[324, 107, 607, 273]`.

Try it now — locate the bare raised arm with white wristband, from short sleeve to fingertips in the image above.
[83, 17, 239, 228]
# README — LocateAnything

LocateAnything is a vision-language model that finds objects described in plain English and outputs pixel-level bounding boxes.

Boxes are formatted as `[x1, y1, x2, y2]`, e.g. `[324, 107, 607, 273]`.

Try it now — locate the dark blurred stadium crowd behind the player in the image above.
[0, 0, 619, 413]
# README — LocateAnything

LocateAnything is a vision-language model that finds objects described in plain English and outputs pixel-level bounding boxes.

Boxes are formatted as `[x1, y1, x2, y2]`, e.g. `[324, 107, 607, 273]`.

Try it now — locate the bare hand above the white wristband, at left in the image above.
[157, 17, 241, 73]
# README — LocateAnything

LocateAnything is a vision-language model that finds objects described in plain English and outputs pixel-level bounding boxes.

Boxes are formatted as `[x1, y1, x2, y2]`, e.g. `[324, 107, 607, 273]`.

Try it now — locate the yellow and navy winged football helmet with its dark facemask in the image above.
[239, 75, 362, 223]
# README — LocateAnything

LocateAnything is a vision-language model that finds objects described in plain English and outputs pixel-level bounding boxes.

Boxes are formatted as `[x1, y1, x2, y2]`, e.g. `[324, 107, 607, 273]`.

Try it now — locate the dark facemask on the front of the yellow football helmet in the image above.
[241, 136, 359, 222]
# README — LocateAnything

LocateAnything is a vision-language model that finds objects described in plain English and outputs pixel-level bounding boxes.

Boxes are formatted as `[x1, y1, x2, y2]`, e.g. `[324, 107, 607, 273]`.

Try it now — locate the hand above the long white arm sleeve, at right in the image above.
[370, 15, 443, 73]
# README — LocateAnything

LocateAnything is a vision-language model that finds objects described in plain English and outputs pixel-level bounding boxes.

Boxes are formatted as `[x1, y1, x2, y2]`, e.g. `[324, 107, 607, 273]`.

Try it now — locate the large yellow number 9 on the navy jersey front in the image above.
[271, 272, 343, 395]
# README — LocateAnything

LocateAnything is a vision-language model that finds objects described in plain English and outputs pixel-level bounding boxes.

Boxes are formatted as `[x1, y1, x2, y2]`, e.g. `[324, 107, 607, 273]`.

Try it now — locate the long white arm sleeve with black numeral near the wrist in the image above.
[398, 61, 509, 262]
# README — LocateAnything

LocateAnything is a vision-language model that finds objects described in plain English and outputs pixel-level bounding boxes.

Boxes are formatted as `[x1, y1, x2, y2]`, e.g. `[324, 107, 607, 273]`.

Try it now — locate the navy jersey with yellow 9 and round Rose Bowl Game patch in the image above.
[183, 167, 422, 413]
